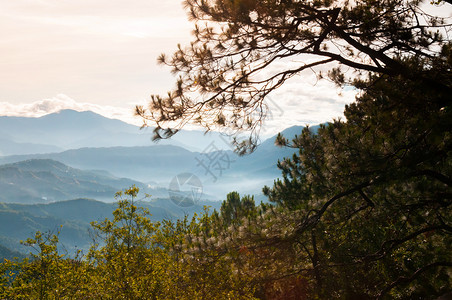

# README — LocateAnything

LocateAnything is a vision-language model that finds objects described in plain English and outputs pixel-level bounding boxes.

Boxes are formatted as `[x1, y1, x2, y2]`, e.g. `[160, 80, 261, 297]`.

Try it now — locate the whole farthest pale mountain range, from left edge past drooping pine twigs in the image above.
[0, 110, 242, 156]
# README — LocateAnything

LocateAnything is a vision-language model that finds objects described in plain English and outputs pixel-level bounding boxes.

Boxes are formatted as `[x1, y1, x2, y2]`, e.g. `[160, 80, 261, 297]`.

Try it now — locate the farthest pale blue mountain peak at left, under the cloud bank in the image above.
[0, 110, 150, 151]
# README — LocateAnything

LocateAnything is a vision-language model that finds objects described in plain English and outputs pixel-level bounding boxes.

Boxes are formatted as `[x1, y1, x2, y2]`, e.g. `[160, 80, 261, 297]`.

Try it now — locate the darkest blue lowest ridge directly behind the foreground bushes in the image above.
[0, 199, 218, 258]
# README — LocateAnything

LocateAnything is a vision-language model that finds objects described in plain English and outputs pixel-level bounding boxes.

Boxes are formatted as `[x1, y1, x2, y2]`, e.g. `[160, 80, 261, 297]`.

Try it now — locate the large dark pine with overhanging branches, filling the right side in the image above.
[132, 0, 452, 299]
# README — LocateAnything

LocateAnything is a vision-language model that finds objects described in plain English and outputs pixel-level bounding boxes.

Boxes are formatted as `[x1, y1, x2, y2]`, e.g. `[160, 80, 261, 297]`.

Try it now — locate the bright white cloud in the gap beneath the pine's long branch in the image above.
[230, 55, 356, 137]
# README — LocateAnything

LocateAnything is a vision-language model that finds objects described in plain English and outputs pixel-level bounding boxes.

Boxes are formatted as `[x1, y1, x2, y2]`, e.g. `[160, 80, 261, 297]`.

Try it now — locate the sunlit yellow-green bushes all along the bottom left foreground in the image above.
[0, 186, 254, 299]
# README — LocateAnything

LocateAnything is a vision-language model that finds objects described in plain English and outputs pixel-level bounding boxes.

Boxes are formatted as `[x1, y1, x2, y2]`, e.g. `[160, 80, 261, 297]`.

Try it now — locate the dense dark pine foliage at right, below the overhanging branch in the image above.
[264, 59, 452, 298]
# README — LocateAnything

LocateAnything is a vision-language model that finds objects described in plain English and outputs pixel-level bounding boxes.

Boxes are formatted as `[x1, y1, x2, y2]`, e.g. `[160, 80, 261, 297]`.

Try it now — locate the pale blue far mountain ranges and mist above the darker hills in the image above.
[0, 110, 308, 200]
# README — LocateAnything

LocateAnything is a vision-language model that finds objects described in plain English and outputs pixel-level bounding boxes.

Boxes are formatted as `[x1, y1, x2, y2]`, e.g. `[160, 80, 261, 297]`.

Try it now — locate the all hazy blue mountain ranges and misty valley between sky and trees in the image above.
[0, 110, 315, 257]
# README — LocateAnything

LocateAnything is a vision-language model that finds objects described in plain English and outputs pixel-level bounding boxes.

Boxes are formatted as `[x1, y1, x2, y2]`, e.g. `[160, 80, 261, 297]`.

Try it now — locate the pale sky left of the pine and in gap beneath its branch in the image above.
[0, 0, 364, 135]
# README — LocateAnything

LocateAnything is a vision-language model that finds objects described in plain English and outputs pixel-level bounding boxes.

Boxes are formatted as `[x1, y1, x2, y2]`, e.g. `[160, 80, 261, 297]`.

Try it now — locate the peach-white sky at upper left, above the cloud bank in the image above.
[0, 0, 191, 107]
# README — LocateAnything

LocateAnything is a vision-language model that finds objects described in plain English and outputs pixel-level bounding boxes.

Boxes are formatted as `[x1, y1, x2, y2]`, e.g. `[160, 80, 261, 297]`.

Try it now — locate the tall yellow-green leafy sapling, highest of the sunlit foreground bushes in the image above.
[88, 186, 165, 299]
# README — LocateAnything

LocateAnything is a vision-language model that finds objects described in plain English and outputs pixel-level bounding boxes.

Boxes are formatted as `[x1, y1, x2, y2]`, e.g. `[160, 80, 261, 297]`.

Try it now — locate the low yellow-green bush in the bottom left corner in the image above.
[0, 231, 91, 299]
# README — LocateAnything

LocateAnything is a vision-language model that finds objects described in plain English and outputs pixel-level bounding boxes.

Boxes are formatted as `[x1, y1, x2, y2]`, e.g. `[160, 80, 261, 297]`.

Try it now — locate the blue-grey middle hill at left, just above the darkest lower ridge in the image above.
[0, 159, 142, 203]
